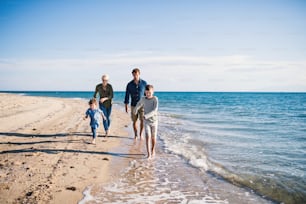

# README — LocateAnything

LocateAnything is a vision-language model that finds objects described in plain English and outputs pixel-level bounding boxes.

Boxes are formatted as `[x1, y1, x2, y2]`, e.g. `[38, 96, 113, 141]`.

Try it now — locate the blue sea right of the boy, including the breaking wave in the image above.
[157, 93, 306, 203]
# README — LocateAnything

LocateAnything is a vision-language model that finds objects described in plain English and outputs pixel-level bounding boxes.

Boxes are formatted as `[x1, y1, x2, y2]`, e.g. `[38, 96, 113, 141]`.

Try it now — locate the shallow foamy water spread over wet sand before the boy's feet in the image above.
[80, 136, 272, 204]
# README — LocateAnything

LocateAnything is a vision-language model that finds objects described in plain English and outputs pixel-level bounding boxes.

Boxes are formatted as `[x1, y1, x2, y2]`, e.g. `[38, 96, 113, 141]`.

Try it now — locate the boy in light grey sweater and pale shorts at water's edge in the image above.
[134, 85, 158, 159]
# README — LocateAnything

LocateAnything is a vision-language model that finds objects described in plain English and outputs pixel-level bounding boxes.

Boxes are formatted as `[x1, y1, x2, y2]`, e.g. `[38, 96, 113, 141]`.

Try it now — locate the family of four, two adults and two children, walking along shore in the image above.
[84, 68, 158, 159]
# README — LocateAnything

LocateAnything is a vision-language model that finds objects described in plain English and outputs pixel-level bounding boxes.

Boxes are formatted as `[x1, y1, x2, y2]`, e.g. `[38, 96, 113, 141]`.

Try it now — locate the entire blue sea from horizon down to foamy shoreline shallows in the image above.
[2, 92, 306, 204]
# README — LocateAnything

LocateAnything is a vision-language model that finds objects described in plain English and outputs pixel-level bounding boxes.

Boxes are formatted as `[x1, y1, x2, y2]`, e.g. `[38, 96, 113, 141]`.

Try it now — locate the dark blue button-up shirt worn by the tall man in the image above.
[124, 79, 147, 106]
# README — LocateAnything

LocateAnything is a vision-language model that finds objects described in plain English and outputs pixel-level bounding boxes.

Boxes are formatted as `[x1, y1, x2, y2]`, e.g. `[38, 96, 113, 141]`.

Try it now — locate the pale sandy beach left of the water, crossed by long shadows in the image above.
[0, 94, 142, 203]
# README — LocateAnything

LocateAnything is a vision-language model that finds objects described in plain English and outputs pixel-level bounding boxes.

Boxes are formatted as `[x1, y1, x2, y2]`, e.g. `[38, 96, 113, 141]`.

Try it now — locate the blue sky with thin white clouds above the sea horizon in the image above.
[0, 0, 306, 92]
